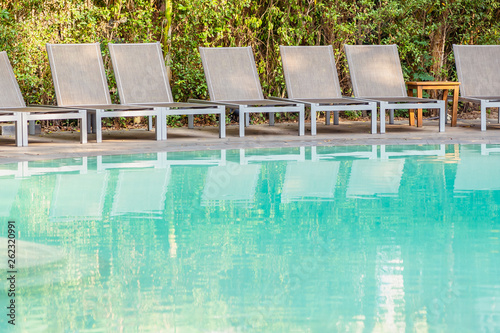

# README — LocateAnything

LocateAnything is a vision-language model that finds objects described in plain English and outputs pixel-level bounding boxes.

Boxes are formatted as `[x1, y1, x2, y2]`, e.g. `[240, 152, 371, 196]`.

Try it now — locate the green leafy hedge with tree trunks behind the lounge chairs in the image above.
[0, 0, 500, 124]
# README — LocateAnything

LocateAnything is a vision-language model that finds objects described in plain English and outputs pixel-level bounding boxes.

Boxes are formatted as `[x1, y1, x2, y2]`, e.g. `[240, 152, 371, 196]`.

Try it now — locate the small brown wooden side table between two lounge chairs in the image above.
[406, 81, 460, 127]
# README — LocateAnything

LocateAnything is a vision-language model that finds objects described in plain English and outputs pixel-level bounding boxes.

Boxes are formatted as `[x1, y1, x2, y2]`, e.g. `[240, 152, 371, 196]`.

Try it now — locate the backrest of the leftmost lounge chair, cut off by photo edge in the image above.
[0, 51, 26, 107]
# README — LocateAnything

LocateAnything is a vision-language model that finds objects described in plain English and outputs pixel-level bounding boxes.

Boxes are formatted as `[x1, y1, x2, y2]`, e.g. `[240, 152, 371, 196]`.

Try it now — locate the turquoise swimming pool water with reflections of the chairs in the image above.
[0, 145, 500, 332]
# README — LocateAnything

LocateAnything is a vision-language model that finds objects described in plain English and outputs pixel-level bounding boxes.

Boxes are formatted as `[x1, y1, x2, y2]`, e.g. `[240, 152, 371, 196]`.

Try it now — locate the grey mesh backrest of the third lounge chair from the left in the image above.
[108, 43, 174, 104]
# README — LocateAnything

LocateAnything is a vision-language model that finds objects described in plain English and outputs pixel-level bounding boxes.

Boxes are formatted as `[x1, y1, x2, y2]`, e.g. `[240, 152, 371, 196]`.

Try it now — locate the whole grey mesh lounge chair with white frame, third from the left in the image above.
[108, 43, 226, 140]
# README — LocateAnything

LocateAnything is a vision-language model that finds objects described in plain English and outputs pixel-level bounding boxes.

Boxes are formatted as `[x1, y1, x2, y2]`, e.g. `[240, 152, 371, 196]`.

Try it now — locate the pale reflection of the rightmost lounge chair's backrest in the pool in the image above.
[454, 146, 500, 192]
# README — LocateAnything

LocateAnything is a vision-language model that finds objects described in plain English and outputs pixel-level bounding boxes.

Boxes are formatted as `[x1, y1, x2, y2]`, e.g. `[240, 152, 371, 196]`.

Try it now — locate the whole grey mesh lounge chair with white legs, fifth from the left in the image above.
[280, 45, 377, 135]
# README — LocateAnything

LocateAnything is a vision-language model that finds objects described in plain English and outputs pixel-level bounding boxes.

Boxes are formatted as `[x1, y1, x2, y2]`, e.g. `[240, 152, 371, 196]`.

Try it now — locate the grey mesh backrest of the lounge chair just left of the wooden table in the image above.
[344, 45, 408, 97]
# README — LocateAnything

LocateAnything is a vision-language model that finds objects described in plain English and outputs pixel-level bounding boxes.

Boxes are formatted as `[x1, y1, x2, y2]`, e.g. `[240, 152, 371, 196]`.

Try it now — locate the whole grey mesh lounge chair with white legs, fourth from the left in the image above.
[195, 47, 304, 137]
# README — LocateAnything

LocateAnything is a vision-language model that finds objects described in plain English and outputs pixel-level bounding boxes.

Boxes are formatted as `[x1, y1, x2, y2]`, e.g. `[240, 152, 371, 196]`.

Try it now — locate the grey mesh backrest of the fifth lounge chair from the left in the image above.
[280, 45, 342, 98]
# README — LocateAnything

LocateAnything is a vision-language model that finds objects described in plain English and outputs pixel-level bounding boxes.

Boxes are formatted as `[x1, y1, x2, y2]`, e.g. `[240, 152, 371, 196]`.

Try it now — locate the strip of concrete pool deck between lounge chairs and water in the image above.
[0, 119, 500, 164]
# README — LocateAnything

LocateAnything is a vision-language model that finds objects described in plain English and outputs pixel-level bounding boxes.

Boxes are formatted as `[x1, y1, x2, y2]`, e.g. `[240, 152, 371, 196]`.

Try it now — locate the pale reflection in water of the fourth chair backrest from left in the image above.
[202, 162, 261, 206]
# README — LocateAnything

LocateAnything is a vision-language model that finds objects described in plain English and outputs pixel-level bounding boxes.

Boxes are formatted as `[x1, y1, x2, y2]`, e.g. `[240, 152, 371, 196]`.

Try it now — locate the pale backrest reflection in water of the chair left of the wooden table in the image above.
[346, 159, 405, 198]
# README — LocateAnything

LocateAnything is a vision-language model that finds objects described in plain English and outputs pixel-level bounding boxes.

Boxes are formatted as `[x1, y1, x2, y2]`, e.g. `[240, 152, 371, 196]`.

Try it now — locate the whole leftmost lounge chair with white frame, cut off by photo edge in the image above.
[0, 51, 87, 147]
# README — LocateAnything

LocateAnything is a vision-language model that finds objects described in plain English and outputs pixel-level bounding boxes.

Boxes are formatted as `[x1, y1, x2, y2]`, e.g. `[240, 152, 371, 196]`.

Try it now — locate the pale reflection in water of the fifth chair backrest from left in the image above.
[281, 161, 340, 202]
